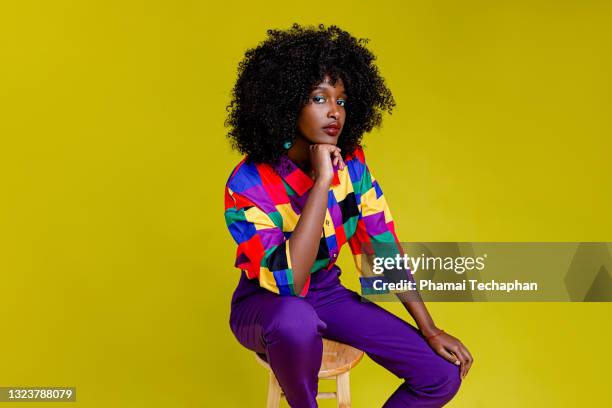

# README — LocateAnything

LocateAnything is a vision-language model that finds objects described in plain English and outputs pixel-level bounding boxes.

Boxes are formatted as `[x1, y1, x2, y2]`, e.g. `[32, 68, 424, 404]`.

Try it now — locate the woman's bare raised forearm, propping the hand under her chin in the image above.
[288, 181, 329, 294]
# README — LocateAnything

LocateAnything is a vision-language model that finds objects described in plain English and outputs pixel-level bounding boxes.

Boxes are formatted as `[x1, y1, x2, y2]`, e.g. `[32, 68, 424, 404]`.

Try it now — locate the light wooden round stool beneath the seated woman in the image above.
[255, 339, 363, 408]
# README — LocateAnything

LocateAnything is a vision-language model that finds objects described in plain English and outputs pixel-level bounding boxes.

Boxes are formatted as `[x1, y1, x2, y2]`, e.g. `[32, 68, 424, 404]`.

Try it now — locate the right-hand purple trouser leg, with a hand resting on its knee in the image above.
[316, 286, 461, 408]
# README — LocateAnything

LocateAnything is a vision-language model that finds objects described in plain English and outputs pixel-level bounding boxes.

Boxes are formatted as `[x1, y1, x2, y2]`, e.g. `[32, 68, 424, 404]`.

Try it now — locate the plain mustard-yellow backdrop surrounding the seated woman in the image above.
[0, 0, 612, 408]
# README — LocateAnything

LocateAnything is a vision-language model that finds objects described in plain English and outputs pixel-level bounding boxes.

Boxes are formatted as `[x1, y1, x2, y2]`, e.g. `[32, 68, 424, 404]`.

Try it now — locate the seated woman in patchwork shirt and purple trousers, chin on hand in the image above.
[225, 24, 472, 408]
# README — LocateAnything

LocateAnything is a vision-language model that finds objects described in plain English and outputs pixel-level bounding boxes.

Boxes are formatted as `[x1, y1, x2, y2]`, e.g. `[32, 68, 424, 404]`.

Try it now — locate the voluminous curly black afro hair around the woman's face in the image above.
[225, 23, 395, 163]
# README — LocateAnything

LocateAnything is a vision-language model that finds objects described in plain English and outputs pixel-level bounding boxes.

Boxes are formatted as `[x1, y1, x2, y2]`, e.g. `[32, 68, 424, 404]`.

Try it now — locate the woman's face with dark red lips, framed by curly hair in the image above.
[297, 76, 346, 145]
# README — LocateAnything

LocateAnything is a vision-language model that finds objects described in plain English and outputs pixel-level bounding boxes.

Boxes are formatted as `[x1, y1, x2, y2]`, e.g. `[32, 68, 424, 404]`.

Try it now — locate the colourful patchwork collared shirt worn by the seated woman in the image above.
[225, 147, 411, 297]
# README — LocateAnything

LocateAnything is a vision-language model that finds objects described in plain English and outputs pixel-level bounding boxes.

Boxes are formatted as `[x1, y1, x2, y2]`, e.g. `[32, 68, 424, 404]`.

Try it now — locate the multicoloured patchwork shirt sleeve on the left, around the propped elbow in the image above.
[225, 186, 310, 297]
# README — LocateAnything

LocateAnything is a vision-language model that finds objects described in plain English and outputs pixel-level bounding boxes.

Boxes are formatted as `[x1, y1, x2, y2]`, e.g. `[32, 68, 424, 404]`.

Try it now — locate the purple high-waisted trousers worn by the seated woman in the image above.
[230, 266, 461, 408]
